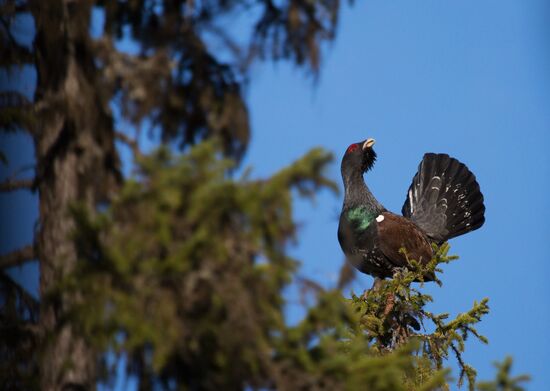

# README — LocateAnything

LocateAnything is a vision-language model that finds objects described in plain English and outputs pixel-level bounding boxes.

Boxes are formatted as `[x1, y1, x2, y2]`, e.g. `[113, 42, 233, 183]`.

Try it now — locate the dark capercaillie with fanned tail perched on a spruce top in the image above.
[338, 139, 485, 281]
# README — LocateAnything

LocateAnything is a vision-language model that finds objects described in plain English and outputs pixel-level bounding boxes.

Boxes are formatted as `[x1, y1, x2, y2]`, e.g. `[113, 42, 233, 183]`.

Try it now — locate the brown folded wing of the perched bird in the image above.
[376, 212, 432, 267]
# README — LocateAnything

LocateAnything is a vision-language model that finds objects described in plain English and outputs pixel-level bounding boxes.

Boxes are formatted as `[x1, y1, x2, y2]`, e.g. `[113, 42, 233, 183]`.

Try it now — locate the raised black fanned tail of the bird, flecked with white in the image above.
[401, 153, 485, 242]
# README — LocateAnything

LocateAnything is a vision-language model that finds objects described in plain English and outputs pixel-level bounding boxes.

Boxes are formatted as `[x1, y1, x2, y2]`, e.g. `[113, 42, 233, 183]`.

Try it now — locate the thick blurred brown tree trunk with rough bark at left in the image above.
[31, 0, 118, 391]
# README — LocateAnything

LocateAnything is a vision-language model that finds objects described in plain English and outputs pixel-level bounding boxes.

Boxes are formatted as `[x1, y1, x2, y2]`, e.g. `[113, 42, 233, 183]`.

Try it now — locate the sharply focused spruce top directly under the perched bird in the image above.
[352, 244, 489, 391]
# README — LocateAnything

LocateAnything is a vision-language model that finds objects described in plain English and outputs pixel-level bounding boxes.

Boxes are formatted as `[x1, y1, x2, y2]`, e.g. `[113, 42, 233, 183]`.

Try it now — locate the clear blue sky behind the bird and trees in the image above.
[0, 0, 550, 390]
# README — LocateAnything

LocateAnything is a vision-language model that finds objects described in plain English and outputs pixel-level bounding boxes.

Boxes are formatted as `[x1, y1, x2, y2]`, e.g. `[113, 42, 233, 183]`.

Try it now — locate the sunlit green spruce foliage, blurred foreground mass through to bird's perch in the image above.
[60, 143, 488, 390]
